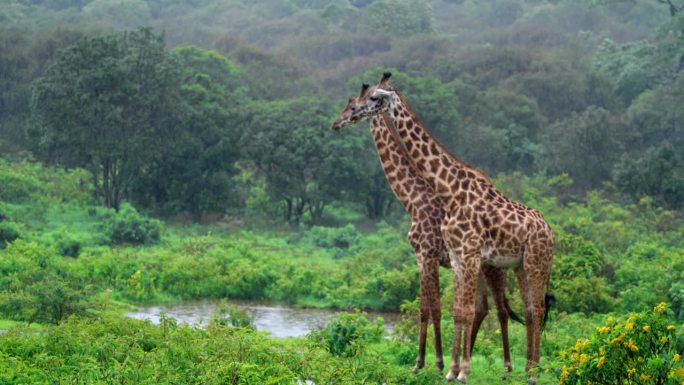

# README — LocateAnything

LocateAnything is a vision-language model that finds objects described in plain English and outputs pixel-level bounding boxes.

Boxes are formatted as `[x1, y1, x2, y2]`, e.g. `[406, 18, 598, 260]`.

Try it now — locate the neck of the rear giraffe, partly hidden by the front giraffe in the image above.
[371, 114, 429, 212]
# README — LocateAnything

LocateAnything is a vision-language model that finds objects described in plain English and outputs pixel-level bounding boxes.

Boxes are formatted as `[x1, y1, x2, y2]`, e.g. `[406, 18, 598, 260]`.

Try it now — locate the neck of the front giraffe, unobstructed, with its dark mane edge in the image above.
[388, 91, 491, 204]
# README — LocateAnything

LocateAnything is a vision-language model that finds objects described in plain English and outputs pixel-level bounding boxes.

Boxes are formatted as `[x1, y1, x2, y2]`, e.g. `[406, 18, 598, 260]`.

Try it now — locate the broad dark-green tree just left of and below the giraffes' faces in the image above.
[240, 97, 363, 223]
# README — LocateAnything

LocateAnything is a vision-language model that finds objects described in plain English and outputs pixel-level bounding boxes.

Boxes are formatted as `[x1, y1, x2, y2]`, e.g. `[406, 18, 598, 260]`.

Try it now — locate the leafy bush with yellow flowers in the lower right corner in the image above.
[560, 303, 684, 385]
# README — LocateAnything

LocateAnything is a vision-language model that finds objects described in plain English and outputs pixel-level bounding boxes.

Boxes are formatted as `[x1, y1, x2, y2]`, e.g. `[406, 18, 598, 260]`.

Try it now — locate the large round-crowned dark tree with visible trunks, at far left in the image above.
[30, 29, 179, 209]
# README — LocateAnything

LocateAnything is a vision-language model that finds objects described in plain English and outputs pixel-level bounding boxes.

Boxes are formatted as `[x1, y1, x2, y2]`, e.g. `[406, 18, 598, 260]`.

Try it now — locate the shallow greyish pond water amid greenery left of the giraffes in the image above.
[126, 301, 400, 338]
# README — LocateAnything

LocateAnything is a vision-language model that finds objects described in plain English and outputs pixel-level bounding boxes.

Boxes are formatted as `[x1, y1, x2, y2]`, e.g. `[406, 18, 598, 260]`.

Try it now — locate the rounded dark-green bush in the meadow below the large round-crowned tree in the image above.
[106, 203, 162, 245]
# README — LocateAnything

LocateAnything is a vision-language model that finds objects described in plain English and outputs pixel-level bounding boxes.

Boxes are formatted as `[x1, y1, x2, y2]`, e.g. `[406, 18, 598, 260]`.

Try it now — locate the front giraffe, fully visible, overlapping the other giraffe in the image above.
[357, 73, 555, 383]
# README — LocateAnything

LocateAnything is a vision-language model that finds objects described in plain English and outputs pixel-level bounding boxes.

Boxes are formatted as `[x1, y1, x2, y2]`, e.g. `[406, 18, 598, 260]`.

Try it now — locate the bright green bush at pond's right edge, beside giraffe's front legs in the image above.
[309, 312, 384, 357]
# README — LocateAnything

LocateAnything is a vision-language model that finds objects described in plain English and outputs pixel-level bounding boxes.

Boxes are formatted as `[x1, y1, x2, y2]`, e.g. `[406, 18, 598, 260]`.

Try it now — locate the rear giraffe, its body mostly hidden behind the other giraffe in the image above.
[331, 84, 522, 372]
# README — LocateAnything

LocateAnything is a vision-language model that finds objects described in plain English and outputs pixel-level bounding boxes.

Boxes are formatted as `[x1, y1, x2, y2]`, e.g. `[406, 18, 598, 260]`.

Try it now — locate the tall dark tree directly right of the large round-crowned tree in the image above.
[130, 45, 248, 220]
